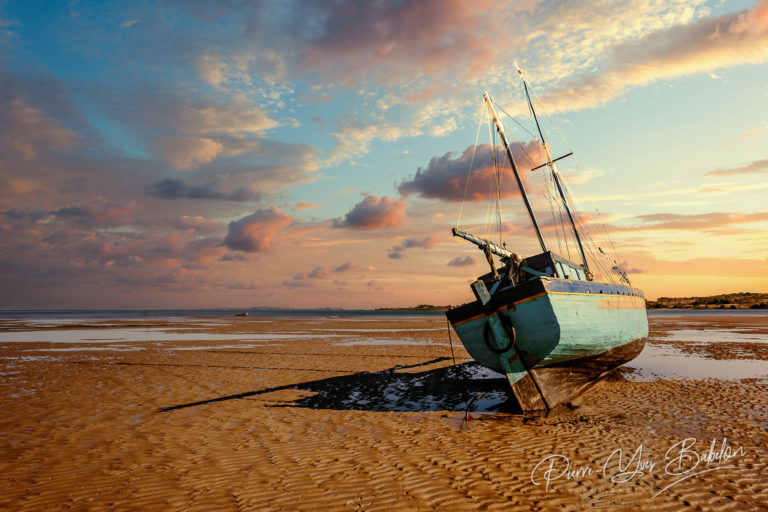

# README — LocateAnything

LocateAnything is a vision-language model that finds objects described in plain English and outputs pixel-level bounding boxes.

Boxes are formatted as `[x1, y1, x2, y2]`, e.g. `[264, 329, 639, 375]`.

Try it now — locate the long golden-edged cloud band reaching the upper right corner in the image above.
[542, 1, 768, 112]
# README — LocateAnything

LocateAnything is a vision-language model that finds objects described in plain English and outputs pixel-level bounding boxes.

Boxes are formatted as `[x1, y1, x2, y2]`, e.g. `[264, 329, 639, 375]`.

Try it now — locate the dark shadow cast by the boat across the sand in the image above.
[158, 357, 520, 413]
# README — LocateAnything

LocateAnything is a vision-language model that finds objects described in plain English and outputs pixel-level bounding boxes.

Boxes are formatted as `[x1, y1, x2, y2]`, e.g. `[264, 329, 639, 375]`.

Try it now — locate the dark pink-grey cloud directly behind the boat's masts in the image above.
[398, 141, 546, 201]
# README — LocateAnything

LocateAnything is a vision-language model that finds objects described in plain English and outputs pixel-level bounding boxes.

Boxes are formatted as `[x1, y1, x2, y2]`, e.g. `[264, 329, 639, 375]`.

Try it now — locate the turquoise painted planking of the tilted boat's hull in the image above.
[454, 278, 648, 378]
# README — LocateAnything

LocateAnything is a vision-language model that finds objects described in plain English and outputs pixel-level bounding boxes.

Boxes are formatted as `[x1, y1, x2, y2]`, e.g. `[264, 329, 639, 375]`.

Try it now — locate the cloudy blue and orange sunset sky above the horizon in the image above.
[0, 0, 768, 309]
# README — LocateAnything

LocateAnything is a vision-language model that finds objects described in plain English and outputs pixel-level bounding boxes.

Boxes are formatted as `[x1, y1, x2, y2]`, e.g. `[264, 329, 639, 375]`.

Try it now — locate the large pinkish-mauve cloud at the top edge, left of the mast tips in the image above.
[299, 0, 522, 83]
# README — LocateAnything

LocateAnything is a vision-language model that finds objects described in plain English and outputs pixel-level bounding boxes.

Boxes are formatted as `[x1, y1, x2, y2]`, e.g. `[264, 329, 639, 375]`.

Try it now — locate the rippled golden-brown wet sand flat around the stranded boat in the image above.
[0, 316, 768, 511]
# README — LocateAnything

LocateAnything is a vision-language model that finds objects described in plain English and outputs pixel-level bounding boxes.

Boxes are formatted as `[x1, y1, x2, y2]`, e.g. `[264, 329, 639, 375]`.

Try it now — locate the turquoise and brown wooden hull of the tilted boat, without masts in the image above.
[446, 277, 648, 411]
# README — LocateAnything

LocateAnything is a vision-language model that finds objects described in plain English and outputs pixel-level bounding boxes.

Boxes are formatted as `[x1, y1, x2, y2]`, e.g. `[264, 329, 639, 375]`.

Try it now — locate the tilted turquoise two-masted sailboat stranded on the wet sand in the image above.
[446, 68, 648, 412]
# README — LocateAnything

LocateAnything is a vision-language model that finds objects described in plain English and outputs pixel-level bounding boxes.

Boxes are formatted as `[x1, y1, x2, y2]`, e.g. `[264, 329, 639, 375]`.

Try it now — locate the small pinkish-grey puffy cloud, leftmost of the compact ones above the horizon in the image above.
[224, 206, 293, 252]
